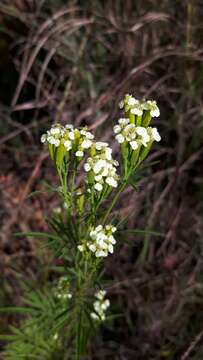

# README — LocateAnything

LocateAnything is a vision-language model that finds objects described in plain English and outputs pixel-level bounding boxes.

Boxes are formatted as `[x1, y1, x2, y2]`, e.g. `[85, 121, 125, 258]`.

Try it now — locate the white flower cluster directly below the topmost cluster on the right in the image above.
[114, 118, 161, 150]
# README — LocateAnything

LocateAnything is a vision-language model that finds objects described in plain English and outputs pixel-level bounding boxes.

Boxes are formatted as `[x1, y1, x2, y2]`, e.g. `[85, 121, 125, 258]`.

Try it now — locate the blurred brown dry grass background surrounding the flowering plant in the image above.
[0, 0, 203, 360]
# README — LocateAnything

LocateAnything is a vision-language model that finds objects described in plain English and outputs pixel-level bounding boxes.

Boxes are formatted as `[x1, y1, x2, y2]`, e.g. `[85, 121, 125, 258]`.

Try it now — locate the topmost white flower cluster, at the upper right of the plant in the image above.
[119, 94, 160, 117]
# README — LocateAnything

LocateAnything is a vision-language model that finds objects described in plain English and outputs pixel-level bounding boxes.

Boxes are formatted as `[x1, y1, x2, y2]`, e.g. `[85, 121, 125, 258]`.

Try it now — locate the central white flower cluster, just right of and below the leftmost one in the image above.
[84, 142, 119, 192]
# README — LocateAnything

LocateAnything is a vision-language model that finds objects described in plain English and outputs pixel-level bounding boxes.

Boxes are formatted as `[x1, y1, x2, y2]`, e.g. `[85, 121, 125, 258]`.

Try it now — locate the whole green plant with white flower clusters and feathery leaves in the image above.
[1, 95, 161, 359]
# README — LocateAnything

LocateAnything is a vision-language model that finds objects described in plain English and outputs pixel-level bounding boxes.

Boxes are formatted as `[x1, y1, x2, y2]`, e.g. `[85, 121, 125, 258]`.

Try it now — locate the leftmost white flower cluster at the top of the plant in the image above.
[41, 124, 94, 157]
